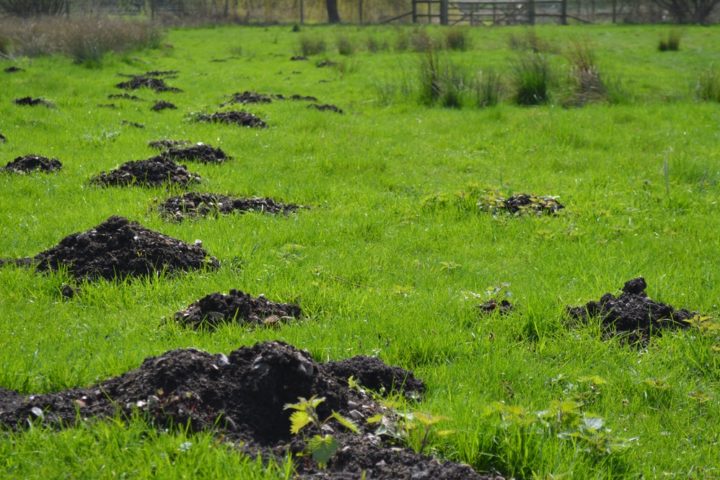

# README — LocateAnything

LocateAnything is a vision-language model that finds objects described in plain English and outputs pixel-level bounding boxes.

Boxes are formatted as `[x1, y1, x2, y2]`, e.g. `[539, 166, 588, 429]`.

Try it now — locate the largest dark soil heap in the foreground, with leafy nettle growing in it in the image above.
[0, 342, 492, 480]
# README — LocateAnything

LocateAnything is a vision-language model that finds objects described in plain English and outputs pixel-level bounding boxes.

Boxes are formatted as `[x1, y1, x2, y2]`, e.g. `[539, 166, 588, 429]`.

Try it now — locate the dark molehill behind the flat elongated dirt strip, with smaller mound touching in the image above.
[90, 156, 200, 187]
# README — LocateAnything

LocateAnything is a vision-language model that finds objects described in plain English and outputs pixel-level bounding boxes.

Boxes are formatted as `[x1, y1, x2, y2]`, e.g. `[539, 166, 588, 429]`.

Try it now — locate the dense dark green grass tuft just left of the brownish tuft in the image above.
[512, 53, 551, 105]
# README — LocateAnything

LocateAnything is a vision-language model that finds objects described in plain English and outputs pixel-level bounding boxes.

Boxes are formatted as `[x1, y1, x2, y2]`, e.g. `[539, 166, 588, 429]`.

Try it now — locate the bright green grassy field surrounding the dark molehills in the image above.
[0, 26, 720, 479]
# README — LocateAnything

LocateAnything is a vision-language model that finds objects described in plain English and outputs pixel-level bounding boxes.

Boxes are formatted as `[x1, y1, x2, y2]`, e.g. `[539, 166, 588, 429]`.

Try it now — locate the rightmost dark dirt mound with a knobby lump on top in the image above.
[567, 277, 696, 343]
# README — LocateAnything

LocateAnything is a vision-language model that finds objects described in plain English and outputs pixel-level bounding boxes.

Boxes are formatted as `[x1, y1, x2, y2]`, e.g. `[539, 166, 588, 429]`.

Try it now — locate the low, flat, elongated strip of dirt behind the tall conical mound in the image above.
[158, 192, 300, 221]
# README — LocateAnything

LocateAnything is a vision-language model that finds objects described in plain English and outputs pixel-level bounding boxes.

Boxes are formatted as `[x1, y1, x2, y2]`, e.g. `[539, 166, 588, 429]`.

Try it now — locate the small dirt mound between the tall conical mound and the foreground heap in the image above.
[175, 289, 302, 328]
